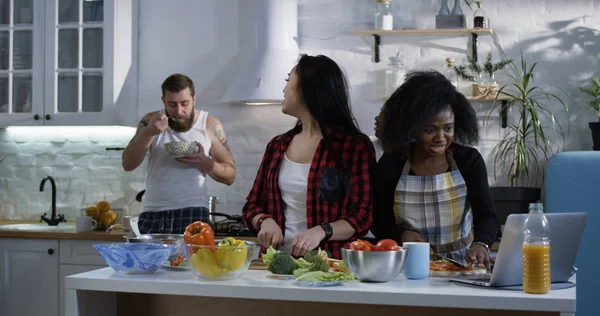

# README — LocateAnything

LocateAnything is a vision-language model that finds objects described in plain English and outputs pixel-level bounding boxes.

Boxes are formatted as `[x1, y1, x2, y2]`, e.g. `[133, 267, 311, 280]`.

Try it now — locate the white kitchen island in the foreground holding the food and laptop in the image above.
[65, 268, 575, 316]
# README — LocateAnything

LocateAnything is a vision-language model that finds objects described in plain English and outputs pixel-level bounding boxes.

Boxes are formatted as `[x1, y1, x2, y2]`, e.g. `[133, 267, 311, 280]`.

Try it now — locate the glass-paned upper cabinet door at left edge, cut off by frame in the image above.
[0, 0, 44, 126]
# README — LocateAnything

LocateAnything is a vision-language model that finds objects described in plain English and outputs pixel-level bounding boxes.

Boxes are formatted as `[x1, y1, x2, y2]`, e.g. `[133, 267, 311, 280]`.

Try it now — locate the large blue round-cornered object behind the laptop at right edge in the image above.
[543, 151, 600, 316]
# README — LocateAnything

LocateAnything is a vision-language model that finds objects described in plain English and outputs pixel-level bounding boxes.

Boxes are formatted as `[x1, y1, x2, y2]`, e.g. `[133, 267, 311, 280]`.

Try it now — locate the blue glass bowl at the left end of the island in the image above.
[94, 243, 176, 274]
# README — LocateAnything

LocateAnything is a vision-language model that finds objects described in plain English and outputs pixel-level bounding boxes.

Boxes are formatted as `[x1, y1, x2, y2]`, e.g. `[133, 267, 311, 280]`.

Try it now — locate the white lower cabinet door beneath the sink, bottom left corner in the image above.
[0, 238, 59, 316]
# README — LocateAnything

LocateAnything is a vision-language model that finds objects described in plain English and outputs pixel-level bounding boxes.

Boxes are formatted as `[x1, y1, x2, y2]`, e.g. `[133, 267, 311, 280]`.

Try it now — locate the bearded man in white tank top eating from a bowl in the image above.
[123, 74, 236, 234]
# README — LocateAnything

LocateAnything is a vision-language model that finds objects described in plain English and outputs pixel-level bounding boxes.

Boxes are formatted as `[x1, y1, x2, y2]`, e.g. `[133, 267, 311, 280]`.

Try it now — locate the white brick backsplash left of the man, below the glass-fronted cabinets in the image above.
[0, 127, 144, 219]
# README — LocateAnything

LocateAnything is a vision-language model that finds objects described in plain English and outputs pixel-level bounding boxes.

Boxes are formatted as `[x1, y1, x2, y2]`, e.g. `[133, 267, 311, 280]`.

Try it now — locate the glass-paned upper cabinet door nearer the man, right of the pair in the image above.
[44, 0, 116, 125]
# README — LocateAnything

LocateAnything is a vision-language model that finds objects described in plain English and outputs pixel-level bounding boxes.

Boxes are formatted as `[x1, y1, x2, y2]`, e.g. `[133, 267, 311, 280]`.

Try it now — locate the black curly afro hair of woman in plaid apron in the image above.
[379, 71, 479, 152]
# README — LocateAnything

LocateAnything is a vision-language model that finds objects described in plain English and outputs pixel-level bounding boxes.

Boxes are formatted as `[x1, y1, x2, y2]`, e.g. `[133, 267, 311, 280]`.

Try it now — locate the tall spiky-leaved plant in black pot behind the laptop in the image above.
[488, 54, 568, 224]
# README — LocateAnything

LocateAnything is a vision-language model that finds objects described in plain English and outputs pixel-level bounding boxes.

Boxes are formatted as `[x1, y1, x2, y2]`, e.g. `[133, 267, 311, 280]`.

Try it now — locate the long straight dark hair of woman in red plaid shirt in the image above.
[296, 54, 360, 135]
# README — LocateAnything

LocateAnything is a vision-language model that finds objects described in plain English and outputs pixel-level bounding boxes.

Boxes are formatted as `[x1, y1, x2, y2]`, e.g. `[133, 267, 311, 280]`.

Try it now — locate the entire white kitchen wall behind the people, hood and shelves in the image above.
[0, 0, 600, 219]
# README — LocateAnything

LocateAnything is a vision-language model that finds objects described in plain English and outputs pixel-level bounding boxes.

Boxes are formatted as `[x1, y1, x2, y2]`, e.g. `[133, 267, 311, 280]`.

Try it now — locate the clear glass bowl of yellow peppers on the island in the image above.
[185, 237, 258, 280]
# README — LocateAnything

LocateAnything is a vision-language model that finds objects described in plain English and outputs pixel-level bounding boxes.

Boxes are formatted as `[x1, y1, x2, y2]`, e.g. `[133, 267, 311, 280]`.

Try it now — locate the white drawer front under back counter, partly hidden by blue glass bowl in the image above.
[60, 240, 110, 266]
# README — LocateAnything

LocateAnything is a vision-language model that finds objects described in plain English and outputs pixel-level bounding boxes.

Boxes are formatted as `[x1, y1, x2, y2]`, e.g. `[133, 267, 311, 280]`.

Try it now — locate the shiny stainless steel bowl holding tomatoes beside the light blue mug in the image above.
[341, 248, 408, 282]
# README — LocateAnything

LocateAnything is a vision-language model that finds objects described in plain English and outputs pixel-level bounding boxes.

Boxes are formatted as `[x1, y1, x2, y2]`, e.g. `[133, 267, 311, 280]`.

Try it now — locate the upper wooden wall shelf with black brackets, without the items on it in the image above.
[352, 28, 494, 63]
